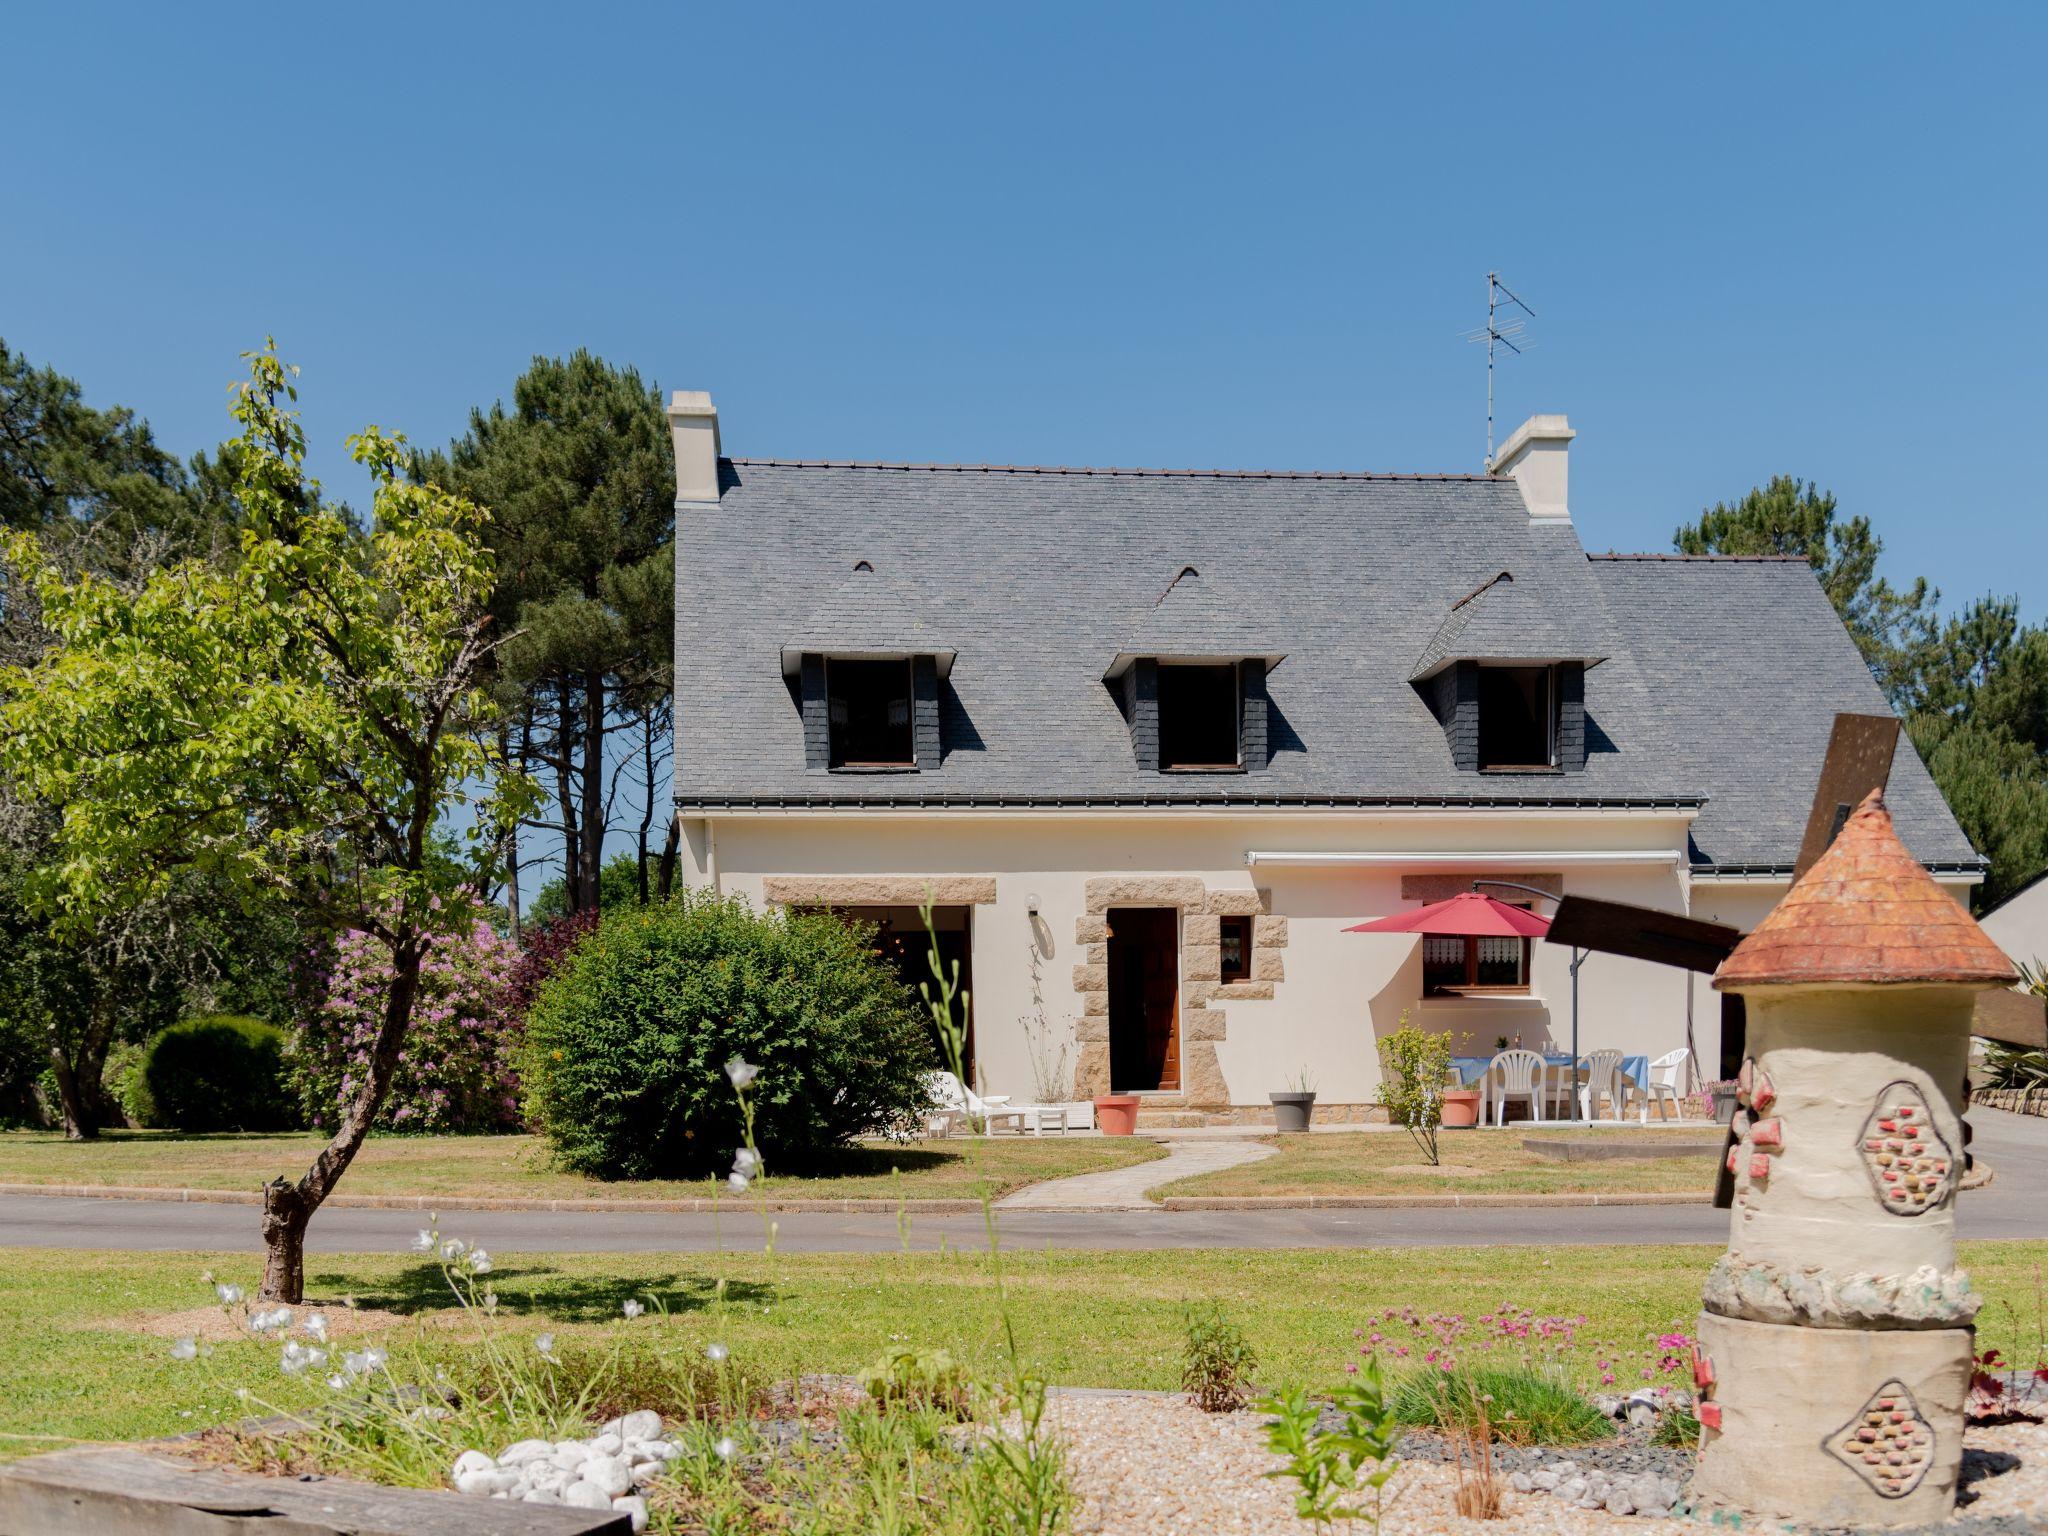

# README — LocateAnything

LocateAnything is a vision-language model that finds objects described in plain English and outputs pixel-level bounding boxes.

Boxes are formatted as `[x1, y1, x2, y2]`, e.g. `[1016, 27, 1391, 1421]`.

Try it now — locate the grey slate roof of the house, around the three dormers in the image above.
[676, 459, 1978, 868]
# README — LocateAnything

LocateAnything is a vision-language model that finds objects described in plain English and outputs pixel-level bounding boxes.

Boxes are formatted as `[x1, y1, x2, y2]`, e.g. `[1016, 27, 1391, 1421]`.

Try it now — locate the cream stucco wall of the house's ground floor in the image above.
[684, 813, 1728, 1104]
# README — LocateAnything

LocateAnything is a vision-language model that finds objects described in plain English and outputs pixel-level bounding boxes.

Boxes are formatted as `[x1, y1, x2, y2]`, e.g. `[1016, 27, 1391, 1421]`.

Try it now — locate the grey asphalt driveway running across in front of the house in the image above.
[0, 1110, 2048, 1264]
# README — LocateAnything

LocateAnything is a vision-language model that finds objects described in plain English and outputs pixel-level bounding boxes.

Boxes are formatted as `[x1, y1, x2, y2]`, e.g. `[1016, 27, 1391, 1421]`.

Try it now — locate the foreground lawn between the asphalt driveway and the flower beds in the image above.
[0, 1245, 2048, 1454]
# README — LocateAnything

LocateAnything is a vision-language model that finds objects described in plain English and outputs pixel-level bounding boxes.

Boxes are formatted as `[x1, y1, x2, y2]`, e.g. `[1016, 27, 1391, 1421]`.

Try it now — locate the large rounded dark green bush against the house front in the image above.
[518, 893, 936, 1178]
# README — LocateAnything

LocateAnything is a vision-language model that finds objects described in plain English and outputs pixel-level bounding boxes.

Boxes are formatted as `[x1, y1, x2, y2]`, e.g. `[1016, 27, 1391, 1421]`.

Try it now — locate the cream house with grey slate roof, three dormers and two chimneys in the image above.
[670, 393, 1980, 1120]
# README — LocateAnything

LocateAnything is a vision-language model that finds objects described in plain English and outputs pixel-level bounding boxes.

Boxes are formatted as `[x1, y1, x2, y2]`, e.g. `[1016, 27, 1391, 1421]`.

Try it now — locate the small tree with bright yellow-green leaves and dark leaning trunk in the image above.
[0, 346, 530, 1300]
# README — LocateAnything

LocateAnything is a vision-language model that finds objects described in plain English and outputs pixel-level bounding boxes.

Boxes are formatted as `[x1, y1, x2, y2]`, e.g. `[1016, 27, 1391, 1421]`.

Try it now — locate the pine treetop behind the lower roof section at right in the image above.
[1671, 475, 1942, 702]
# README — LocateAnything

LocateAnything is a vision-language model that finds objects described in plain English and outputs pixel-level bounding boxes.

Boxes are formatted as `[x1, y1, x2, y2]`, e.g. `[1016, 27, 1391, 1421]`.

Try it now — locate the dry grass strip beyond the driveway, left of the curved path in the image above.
[0, 1130, 1165, 1200]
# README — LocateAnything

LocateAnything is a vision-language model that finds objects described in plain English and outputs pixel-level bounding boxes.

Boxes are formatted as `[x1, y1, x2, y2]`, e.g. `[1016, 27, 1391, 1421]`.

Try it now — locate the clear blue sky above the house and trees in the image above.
[0, 4, 2048, 876]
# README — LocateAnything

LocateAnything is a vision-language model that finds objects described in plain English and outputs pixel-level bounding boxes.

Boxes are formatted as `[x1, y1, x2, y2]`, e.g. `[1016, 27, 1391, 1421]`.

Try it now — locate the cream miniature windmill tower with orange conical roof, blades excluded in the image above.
[1694, 791, 2017, 1528]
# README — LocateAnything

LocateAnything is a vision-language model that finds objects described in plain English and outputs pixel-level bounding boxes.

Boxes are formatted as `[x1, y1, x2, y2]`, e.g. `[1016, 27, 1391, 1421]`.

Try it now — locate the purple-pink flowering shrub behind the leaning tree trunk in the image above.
[289, 924, 522, 1135]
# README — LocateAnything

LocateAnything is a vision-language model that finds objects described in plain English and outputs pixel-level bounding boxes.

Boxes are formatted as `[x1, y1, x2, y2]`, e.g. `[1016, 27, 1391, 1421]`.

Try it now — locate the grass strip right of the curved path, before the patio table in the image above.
[1153, 1126, 1718, 1200]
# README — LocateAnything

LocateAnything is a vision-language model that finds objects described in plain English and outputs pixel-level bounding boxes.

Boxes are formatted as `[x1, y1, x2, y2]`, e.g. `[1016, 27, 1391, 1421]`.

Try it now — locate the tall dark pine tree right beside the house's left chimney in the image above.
[416, 352, 676, 911]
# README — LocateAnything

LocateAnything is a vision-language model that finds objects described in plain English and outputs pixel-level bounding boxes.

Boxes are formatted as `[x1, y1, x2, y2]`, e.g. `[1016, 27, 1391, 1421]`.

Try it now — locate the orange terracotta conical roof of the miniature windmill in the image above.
[1714, 788, 2019, 989]
